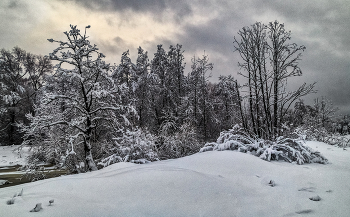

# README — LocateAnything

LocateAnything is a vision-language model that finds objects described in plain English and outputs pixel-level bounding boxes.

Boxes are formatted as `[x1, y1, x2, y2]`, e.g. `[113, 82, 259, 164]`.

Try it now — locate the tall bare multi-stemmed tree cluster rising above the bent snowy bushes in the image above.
[234, 21, 315, 138]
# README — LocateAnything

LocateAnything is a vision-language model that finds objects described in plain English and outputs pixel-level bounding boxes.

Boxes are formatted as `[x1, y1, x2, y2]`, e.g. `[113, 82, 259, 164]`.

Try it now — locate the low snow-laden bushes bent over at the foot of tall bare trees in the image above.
[200, 125, 328, 164]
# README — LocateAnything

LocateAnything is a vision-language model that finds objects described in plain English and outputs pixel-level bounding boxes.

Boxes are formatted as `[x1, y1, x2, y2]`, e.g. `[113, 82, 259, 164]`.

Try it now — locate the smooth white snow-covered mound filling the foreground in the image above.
[0, 142, 350, 217]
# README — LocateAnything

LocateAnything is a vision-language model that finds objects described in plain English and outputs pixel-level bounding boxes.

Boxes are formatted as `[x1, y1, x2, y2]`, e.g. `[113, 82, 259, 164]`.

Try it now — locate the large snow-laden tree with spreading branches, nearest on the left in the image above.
[24, 25, 134, 171]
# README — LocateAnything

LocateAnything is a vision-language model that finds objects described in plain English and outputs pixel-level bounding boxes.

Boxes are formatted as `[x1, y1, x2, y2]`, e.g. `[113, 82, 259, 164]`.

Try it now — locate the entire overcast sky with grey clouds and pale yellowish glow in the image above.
[0, 0, 350, 114]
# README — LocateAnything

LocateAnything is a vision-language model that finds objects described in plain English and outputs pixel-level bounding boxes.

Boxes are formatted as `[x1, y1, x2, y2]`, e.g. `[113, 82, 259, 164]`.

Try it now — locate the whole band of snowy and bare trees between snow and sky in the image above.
[0, 21, 350, 171]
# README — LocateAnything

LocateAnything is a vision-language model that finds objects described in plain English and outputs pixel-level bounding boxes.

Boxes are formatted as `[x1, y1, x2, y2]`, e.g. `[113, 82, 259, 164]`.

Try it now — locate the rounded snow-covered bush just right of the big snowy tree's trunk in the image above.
[97, 129, 158, 168]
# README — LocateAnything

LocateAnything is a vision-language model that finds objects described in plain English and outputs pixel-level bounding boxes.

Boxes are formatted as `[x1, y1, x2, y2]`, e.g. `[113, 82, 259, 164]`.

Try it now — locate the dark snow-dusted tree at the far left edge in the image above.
[0, 47, 52, 145]
